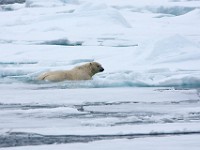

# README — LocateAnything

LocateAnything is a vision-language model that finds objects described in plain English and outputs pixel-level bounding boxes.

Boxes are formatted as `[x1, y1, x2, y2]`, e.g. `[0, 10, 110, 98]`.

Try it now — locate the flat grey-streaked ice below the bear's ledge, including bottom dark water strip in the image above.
[0, 88, 200, 147]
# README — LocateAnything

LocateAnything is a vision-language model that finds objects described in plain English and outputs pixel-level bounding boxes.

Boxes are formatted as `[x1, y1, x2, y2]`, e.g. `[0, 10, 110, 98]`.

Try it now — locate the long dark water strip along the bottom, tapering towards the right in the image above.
[0, 131, 200, 147]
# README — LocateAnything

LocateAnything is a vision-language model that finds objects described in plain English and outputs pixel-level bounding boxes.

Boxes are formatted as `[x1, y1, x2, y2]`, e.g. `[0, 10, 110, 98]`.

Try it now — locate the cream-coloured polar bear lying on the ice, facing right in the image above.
[37, 62, 104, 82]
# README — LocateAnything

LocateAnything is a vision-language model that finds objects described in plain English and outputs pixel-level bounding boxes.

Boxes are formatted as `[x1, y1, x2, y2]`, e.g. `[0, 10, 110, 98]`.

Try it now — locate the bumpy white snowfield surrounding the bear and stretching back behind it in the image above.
[0, 0, 200, 88]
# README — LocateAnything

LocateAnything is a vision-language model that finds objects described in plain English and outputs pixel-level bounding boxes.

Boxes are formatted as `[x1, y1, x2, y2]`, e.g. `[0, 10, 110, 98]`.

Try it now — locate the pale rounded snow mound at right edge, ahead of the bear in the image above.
[148, 35, 200, 63]
